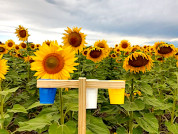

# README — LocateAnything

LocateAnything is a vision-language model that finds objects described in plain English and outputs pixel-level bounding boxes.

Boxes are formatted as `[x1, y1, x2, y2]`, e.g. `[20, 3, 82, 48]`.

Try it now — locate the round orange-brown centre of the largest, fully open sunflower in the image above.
[43, 53, 64, 74]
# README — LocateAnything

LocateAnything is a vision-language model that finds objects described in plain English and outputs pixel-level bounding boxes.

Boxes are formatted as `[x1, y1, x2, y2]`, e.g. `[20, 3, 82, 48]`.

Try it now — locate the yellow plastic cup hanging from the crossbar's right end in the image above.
[108, 80, 125, 104]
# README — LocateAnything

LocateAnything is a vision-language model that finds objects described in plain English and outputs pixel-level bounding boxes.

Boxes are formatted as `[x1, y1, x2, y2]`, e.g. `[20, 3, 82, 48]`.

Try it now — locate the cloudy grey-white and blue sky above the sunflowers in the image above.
[0, 0, 178, 47]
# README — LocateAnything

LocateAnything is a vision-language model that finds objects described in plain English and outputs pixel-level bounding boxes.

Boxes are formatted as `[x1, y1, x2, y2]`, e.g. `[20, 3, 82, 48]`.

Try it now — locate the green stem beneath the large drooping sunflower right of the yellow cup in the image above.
[129, 79, 134, 134]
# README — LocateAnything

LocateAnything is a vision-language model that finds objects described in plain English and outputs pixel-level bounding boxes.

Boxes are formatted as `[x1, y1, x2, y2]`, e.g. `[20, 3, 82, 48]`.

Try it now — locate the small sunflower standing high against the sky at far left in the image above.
[15, 25, 30, 41]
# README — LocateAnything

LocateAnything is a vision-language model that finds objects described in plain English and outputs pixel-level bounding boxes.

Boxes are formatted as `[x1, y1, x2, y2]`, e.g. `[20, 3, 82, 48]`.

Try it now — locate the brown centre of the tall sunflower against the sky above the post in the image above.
[68, 32, 82, 47]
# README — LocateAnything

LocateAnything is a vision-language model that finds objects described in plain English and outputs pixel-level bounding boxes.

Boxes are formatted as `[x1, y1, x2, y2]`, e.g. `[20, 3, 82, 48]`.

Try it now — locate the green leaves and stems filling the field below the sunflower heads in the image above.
[0, 48, 178, 134]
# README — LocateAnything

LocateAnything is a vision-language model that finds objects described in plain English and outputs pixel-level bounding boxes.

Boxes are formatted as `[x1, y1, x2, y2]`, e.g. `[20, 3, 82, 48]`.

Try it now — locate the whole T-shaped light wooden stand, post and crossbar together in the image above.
[37, 77, 125, 134]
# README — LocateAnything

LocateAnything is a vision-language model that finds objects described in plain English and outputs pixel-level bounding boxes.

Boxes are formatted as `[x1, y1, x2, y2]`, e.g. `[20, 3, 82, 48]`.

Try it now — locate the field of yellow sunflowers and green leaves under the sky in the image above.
[0, 26, 178, 134]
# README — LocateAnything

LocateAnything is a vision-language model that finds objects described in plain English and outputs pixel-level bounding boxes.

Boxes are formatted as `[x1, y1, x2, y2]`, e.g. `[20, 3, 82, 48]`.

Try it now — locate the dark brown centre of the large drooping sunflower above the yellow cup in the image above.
[129, 55, 149, 67]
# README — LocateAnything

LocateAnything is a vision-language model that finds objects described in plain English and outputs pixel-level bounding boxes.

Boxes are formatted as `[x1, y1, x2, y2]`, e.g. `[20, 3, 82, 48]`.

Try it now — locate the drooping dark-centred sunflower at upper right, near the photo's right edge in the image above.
[155, 44, 175, 58]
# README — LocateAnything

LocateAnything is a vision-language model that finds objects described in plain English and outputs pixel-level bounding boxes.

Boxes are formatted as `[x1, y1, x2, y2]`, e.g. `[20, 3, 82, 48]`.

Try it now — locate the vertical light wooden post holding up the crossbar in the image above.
[78, 77, 86, 134]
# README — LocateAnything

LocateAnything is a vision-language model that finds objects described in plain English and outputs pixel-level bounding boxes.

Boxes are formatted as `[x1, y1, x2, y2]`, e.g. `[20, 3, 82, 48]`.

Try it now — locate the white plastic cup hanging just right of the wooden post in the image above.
[86, 79, 98, 109]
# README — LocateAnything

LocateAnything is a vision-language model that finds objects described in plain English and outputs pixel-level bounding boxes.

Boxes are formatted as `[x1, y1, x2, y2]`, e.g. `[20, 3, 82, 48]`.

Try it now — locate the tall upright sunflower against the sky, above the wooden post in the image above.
[62, 27, 87, 52]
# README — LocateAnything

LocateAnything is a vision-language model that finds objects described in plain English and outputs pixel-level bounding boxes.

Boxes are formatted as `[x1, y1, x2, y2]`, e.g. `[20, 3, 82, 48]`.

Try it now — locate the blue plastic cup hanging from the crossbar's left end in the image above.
[39, 79, 57, 104]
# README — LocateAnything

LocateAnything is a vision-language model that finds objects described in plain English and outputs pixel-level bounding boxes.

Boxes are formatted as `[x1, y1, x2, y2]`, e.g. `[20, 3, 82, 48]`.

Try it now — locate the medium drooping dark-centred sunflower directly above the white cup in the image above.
[87, 47, 105, 62]
